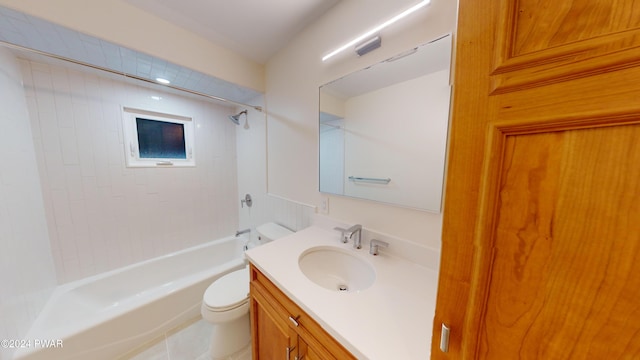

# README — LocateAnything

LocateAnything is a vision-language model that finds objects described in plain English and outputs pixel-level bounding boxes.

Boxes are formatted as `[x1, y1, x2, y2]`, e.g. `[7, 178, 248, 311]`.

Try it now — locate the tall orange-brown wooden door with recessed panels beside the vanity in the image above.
[432, 0, 640, 360]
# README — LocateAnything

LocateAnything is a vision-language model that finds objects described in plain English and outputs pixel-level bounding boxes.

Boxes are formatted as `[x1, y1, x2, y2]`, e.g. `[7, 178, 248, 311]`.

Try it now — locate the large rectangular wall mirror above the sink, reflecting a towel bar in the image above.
[319, 34, 452, 212]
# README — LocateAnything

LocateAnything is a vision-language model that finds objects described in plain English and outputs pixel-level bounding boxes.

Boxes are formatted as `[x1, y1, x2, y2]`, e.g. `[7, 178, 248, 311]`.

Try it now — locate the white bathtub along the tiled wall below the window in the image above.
[14, 234, 249, 360]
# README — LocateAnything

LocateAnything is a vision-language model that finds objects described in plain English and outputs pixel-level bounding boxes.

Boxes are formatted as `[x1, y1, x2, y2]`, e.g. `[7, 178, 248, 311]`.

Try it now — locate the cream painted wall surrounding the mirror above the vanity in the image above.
[266, 0, 457, 252]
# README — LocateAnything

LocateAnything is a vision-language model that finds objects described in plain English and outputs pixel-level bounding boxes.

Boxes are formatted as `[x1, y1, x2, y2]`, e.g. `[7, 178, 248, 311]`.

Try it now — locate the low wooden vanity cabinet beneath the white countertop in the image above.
[250, 265, 355, 360]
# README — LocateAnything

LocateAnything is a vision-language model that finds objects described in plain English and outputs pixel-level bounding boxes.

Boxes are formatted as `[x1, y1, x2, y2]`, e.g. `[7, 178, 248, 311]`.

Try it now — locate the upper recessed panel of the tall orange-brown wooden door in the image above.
[491, 0, 640, 94]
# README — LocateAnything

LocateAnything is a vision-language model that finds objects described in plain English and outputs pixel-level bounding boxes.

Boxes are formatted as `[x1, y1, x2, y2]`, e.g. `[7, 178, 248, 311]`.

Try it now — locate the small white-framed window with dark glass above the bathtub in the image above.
[123, 107, 195, 167]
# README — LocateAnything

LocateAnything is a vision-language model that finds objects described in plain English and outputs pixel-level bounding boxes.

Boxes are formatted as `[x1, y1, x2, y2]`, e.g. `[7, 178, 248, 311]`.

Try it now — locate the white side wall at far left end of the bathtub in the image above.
[0, 48, 56, 359]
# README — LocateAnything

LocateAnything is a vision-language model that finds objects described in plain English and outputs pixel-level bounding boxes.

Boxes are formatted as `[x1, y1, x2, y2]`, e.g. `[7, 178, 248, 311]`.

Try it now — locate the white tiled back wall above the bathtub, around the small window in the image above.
[21, 60, 239, 283]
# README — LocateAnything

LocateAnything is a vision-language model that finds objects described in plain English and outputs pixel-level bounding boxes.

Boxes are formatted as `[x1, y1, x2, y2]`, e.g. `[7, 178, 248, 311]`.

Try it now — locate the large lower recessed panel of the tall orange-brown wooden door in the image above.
[479, 125, 640, 359]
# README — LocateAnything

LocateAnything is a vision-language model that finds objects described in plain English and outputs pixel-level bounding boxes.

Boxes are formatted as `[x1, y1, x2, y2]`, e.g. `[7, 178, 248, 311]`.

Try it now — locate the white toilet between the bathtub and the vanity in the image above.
[200, 223, 292, 360]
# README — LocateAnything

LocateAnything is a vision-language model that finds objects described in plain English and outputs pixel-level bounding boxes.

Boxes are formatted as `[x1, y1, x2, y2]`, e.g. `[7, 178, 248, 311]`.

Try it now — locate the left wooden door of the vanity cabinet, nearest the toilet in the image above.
[250, 284, 297, 360]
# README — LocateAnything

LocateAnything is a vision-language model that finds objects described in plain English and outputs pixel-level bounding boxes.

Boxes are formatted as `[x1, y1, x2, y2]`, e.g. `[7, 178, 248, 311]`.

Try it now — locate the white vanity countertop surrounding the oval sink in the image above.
[246, 226, 438, 360]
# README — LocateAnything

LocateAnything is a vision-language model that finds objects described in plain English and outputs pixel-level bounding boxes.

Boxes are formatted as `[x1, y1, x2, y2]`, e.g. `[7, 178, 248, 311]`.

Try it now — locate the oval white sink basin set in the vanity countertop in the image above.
[298, 246, 376, 292]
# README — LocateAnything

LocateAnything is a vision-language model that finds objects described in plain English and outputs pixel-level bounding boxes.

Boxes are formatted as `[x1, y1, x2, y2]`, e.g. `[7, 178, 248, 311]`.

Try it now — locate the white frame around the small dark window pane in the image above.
[122, 107, 196, 167]
